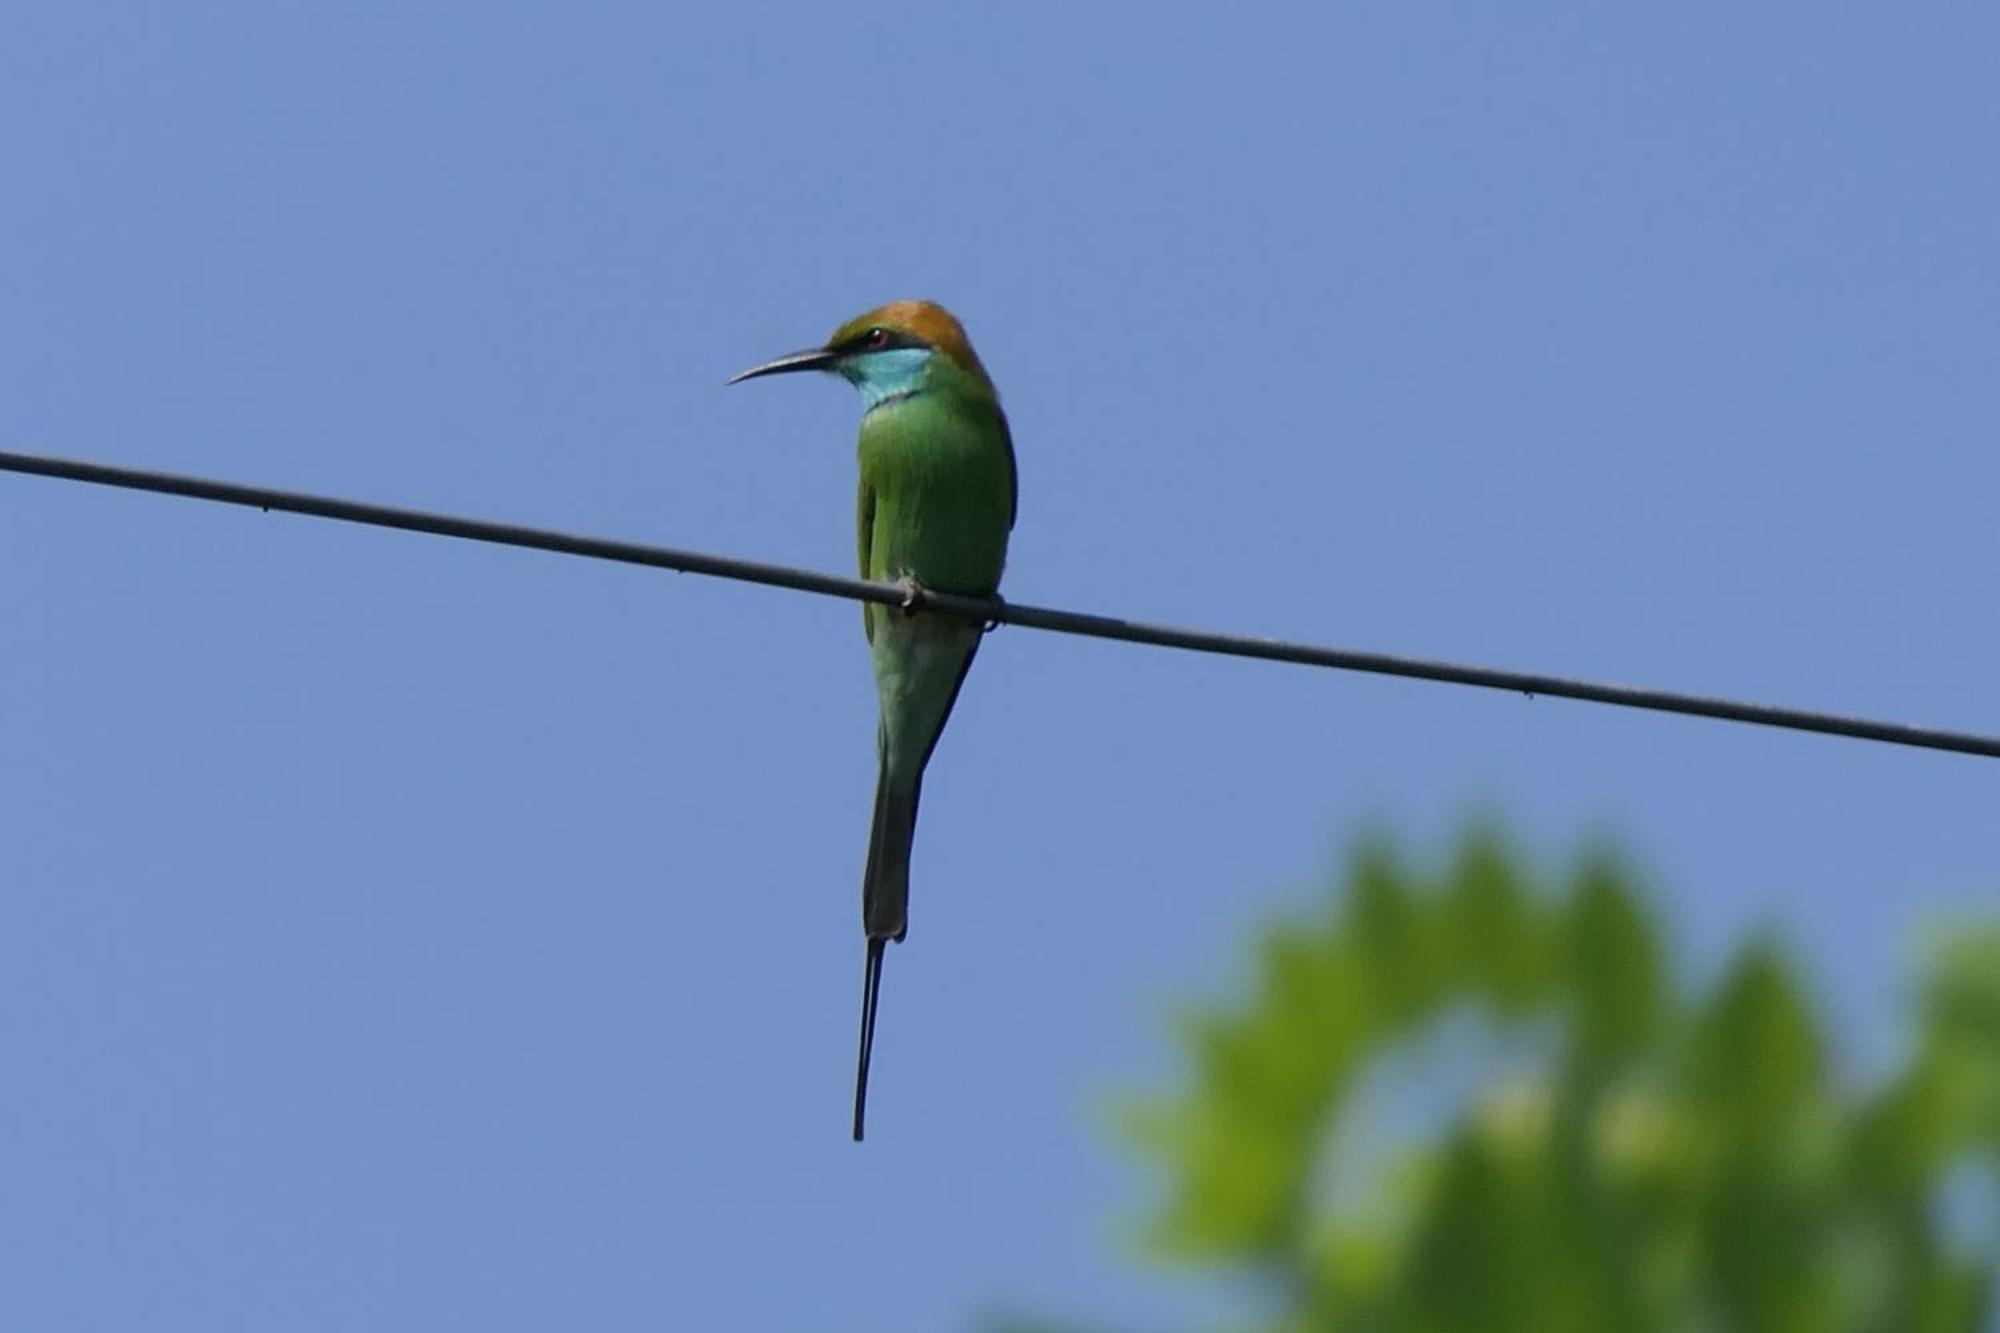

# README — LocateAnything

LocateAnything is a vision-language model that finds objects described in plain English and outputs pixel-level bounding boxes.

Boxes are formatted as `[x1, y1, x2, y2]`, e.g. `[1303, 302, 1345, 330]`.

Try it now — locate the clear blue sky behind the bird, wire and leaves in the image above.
[0, 0, 2000, 1331]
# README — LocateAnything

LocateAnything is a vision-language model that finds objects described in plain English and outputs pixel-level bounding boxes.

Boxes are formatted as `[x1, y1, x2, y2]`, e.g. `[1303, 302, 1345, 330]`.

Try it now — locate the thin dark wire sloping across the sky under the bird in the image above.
[0, 450, 2000, 759]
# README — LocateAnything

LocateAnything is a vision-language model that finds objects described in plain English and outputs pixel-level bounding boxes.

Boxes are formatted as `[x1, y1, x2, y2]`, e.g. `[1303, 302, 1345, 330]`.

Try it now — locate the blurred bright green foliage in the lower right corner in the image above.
[1128, 829, 2000, 1333]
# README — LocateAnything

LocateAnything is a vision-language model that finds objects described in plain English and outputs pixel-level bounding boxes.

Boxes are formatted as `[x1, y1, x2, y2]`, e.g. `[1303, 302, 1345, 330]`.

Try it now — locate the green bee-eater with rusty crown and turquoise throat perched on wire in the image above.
[730, 300, 1016, 1143]
